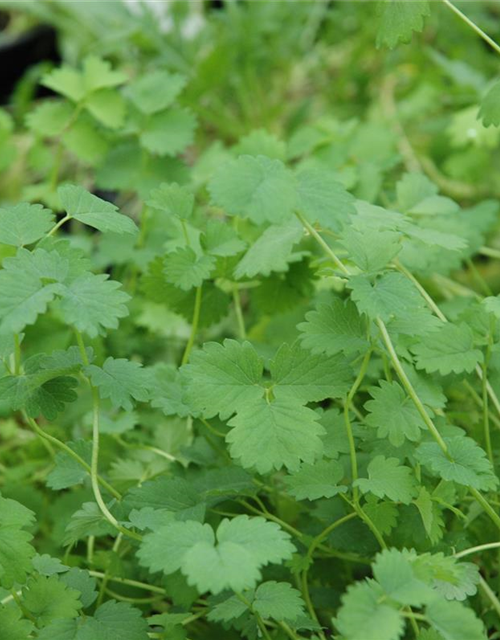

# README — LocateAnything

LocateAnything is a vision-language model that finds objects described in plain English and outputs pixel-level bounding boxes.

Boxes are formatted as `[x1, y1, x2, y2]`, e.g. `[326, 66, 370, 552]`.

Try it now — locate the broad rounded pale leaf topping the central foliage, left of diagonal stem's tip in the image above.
[208, 156, 296, 224]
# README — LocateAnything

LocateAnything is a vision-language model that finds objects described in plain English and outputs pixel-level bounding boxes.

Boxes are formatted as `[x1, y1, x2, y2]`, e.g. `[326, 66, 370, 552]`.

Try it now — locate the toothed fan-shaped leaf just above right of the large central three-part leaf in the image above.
[297, 298, 368, 355]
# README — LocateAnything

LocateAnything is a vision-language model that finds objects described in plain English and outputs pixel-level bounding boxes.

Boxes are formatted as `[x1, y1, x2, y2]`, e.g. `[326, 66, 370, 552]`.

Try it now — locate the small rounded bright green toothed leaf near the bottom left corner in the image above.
[23, 575, 82, 627]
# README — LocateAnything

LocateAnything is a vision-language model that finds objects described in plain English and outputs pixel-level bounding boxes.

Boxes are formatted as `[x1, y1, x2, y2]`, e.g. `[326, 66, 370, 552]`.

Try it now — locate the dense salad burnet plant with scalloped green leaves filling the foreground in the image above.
[0, 0, 500, 640]
